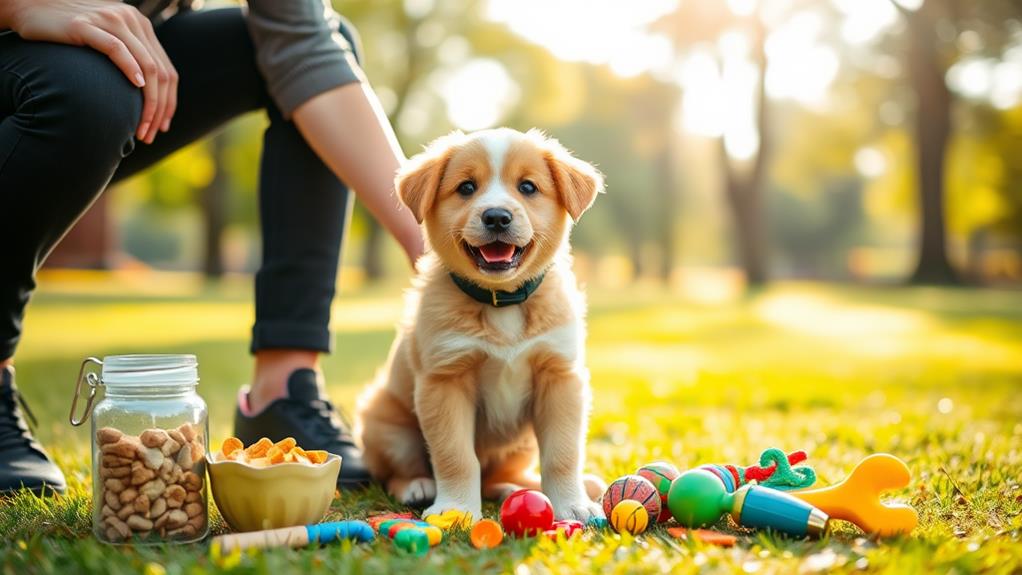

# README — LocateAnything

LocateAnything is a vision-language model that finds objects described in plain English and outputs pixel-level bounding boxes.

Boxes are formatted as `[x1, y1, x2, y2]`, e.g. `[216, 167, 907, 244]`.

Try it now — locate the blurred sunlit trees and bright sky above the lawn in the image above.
[50, 0, 1022, 290]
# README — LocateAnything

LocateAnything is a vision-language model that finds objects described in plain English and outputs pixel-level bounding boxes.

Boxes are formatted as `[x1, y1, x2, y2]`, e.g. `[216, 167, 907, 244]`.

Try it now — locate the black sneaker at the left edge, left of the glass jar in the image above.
[0, 367, 65, 494]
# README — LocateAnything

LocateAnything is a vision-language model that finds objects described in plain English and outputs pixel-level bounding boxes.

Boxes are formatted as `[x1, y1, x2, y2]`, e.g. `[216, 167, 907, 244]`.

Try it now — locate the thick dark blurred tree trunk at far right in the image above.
[902, 2, 960, 285]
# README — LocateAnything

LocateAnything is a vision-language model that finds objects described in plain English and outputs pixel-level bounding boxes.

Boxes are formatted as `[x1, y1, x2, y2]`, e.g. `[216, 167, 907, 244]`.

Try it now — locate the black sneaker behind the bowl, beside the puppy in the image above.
[234, 369, 372, 489]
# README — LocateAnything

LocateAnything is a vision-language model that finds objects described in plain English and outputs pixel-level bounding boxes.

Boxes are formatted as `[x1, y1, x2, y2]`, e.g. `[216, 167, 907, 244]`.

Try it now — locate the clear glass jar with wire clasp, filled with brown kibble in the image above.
[71, 354, 210, 543]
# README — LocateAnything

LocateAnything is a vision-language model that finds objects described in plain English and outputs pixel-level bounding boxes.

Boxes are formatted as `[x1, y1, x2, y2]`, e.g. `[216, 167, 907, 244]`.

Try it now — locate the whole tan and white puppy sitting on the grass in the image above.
[356, 129, 603, 521]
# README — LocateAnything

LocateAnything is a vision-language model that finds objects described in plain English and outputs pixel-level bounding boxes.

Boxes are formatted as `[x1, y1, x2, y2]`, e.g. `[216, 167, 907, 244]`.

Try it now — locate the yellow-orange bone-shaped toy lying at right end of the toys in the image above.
[790, 453, 919, 536]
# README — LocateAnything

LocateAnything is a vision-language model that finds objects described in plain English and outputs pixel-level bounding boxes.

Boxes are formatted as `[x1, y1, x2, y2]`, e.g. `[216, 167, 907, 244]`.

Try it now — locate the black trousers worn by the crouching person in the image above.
[0, 8, 358, 361]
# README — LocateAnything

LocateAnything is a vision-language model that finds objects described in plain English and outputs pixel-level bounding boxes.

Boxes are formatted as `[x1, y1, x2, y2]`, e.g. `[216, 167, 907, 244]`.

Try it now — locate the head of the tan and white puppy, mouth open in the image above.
[397, 129, 603, 289]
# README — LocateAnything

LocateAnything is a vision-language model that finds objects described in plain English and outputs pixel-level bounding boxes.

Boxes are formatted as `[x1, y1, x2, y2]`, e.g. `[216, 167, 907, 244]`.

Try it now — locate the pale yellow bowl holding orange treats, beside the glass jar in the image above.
[206, 453, 340, 531]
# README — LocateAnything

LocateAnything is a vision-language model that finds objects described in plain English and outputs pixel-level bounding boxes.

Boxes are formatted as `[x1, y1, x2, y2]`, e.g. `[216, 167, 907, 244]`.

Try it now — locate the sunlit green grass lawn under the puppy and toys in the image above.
[0, 278, 1022, 574]
